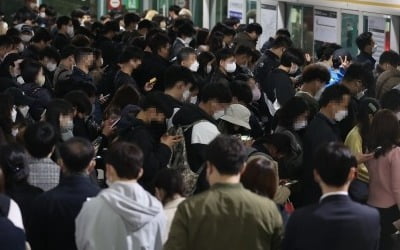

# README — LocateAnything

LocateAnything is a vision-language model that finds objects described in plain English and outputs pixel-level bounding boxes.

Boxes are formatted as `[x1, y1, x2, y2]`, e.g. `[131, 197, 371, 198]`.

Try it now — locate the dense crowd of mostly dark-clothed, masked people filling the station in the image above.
[0, 0, 400, 250]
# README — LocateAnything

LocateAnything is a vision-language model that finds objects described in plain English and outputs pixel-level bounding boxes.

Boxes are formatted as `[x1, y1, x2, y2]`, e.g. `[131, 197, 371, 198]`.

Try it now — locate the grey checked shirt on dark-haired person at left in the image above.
[28, 157, 61, 191]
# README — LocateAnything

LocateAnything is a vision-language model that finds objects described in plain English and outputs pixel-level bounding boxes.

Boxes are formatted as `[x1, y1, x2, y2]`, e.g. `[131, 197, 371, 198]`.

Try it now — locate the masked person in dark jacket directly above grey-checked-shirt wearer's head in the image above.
[20, 60, 52, 121]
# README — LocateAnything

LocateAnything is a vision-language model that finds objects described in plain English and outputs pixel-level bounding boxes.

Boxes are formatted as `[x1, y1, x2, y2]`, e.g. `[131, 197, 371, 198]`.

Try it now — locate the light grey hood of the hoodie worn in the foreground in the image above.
[99, 182, 163, 232]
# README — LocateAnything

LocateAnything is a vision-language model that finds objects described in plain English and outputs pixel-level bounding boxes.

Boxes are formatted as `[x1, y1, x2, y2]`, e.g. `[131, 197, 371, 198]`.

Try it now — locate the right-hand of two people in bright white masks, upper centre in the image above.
[210, 49, 236, 86]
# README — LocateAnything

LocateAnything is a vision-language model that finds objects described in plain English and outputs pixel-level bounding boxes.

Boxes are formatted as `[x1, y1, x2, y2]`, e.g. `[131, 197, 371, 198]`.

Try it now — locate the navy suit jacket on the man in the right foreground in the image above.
[282, 195, 380, 250]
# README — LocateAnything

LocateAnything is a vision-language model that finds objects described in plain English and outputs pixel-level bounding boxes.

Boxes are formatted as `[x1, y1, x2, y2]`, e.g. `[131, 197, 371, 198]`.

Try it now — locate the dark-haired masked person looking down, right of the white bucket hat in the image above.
[274, 97, 309, 179]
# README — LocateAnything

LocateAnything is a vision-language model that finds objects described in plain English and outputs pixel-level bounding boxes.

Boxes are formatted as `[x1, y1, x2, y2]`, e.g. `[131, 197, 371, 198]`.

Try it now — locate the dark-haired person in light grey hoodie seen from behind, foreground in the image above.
[75, 142, 166, 250]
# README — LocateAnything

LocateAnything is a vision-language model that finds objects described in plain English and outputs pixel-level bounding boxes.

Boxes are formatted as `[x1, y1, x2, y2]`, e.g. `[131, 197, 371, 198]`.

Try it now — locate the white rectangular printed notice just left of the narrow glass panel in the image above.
[314, 10, 337, 43]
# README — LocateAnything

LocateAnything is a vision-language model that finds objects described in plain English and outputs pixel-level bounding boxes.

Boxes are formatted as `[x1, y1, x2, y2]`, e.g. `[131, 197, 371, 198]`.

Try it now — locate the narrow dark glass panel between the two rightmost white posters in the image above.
[341, 13, 358, 57]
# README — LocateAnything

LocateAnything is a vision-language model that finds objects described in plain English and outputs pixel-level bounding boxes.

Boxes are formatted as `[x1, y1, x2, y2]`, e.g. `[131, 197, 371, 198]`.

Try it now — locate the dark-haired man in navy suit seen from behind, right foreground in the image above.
[283, 142, 380, 250]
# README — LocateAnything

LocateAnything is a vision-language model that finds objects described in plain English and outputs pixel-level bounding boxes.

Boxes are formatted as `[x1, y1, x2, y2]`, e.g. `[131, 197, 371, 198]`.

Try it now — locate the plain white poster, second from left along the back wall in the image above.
[257, 4, 277, 48]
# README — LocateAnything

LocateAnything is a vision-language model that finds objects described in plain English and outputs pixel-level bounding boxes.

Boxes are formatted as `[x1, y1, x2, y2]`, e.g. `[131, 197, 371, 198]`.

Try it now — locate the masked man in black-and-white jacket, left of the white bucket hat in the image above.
[172, 82, 232, 192]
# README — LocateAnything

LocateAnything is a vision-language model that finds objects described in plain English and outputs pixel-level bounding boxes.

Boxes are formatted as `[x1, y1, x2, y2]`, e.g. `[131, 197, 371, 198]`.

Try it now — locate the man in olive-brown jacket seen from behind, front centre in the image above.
[164, 135, 283, 250]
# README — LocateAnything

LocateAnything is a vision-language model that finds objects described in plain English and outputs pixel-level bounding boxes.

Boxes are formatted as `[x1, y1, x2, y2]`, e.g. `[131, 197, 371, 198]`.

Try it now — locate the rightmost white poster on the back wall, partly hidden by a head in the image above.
[368, 16, 386, 61]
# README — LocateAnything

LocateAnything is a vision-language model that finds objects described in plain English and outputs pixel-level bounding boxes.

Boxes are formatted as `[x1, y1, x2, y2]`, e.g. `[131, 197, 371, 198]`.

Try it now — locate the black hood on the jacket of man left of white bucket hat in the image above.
[172, 104, 216, 126]
